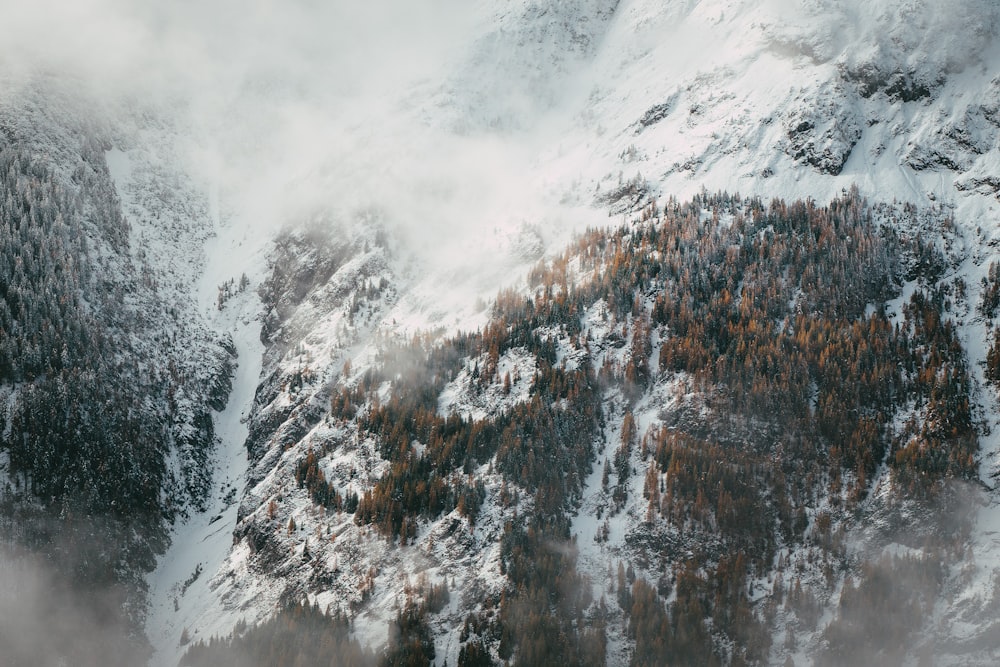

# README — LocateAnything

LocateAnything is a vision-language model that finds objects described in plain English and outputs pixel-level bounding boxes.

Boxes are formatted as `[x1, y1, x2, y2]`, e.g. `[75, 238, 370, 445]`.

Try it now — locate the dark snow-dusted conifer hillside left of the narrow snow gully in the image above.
[0, 108, 234, 665]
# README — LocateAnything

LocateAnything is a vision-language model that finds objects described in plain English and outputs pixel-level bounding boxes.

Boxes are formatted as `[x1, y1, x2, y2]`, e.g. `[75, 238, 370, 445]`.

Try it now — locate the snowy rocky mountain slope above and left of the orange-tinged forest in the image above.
[131, 0, 1000, 664]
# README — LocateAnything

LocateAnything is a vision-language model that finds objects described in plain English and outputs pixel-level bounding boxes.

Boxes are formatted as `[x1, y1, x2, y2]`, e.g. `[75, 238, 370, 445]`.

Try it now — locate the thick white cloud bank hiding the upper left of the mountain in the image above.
[0, 0, 612, 328]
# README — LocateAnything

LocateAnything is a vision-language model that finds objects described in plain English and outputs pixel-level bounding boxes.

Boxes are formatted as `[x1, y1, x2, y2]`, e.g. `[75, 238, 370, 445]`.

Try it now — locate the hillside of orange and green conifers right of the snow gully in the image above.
[184, 193, 978, 665]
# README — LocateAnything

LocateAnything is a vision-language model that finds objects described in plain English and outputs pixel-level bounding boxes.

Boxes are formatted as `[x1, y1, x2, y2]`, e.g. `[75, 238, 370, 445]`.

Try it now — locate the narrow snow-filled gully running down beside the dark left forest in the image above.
[106, 127, 270, 667]
